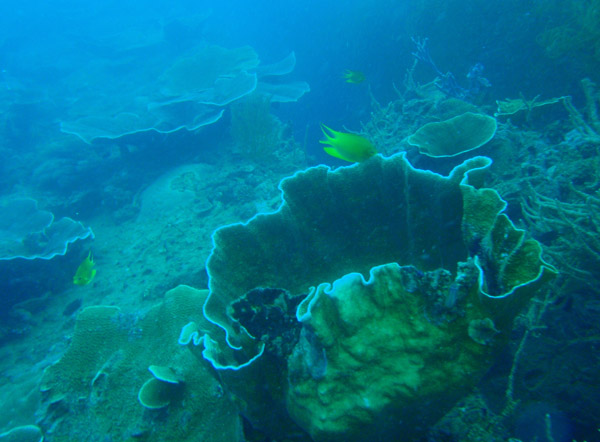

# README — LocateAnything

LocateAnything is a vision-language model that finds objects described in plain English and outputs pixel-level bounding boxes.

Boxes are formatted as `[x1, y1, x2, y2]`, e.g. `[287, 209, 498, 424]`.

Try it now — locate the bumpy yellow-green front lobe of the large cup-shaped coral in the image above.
[287, 263, 494, 441]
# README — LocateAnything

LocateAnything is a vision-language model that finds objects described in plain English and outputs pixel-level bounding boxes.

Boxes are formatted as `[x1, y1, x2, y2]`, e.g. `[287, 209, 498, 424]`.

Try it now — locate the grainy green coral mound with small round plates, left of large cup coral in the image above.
[41, 286, 243, 442]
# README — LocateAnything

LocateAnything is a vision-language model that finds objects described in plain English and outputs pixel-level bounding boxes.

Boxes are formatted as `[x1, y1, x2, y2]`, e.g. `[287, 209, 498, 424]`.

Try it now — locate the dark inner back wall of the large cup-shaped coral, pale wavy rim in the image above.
[204, 154, 482, 365]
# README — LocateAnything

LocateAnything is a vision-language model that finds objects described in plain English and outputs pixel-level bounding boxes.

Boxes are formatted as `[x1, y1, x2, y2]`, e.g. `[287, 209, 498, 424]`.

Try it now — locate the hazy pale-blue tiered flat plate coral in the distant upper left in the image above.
[61, 45, 310, 143]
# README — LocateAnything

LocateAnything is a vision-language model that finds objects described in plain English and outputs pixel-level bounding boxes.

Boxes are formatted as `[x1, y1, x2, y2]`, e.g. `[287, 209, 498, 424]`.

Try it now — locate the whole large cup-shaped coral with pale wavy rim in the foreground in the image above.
[182, 154, 555, 440]
